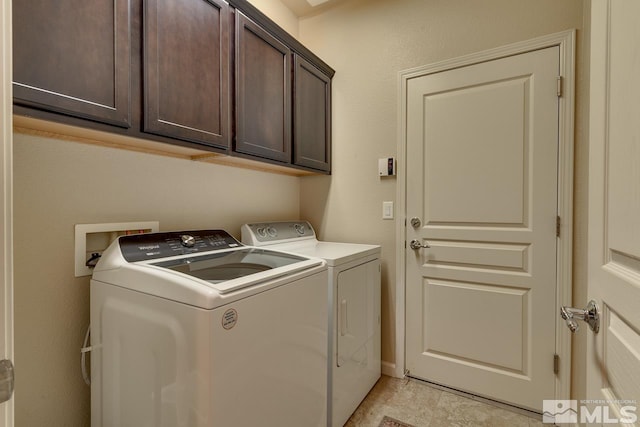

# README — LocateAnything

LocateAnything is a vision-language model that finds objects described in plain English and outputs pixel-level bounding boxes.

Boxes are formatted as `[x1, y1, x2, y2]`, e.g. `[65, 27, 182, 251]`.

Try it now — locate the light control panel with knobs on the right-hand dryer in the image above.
[241, 221, 316, 246]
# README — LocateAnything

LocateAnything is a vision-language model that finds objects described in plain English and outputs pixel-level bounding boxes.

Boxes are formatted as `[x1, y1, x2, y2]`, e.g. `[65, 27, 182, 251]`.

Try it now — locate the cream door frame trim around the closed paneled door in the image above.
[392, 29, 576, 399]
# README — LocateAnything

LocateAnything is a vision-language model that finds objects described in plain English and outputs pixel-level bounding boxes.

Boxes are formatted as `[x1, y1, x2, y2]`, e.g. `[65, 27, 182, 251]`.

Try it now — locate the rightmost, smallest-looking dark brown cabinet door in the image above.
[293, 55, 331, 172]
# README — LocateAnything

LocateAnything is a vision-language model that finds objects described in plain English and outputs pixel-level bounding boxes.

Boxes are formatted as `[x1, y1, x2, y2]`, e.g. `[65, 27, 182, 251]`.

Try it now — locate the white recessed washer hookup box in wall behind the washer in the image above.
[75, 221, 160, 277]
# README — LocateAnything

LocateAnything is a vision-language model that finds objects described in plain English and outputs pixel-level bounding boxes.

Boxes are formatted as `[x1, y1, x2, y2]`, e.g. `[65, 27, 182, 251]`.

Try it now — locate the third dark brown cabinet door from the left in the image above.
[234, 12, 291, 163]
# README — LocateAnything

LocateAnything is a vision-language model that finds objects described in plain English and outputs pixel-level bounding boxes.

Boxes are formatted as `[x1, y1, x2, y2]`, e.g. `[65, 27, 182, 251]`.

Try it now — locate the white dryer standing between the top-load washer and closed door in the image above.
[241, 221, 381, 427]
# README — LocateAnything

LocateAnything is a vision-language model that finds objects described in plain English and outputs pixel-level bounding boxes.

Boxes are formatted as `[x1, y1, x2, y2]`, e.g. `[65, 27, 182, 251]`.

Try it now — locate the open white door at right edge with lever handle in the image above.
[578, 0, 640, 425]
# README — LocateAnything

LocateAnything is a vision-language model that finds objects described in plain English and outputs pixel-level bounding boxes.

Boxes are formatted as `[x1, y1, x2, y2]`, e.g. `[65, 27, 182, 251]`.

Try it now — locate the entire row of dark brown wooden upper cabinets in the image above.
[13, 0, 334, 174]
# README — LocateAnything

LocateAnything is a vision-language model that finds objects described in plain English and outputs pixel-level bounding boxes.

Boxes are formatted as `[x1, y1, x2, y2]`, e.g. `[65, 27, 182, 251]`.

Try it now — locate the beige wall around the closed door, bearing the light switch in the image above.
[300, 0, 587, 382]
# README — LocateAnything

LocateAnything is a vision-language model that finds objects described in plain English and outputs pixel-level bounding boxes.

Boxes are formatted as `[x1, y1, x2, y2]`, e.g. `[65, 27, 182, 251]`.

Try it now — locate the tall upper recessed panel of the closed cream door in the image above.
[424, 78, 530, 226]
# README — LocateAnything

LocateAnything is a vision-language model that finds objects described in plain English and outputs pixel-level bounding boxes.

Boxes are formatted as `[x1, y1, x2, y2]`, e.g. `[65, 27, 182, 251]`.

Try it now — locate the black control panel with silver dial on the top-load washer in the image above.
[118, 230, 242, 262]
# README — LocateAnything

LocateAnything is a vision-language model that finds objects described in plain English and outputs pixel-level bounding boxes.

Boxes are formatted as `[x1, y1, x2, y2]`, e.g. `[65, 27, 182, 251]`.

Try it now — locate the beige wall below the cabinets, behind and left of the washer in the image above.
[14, 134, 299, 427]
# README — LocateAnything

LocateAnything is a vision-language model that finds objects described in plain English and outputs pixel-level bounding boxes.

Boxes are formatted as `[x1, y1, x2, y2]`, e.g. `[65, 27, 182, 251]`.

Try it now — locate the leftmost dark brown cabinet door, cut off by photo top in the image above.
[13, 0, 131, 127]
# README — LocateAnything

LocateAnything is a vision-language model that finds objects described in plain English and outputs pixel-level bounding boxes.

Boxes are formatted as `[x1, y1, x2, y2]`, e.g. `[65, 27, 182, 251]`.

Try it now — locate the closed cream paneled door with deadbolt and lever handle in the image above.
[406, 46, 560, 411]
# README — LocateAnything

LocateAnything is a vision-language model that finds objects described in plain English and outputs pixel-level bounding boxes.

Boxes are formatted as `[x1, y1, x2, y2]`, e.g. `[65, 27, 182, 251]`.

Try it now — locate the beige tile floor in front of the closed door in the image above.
[345, 375, 549, 427]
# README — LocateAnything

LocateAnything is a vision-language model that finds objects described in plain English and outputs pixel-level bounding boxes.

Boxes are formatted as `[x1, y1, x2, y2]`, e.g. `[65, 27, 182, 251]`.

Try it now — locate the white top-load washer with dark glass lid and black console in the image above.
[91, 230, 328, 427]
